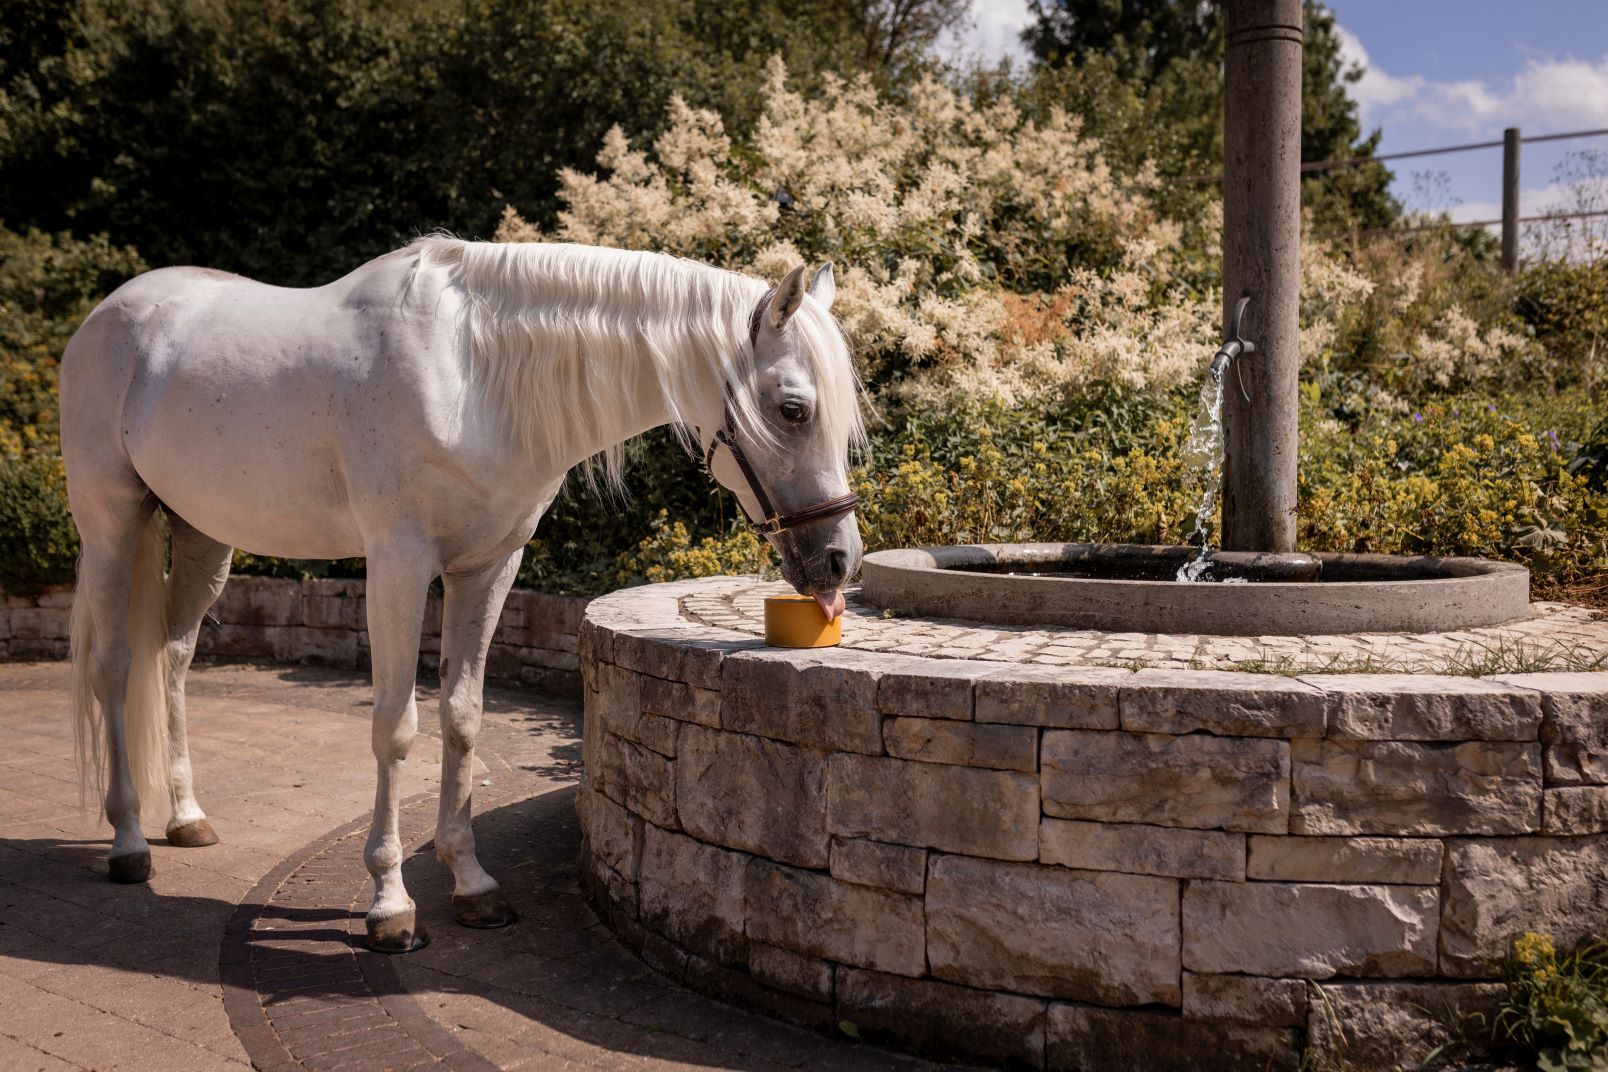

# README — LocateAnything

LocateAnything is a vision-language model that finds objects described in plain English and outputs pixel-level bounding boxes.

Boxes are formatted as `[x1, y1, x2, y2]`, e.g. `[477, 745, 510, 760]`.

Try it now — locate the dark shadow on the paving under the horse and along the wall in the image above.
[0, 786, 907, 1069]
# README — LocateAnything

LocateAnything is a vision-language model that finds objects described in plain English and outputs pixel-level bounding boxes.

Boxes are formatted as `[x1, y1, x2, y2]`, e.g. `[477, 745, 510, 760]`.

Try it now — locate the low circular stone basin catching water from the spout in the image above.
[862, 543, 1529, 636]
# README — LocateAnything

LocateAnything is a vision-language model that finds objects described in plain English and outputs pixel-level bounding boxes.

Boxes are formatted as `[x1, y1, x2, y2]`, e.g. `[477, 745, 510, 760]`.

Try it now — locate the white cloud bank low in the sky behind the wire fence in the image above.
[1339, 29, 1608, 138]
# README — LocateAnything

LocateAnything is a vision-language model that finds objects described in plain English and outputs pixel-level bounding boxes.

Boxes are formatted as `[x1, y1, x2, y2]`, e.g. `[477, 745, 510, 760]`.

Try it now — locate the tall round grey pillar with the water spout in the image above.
[1222, 0, 1301, 551]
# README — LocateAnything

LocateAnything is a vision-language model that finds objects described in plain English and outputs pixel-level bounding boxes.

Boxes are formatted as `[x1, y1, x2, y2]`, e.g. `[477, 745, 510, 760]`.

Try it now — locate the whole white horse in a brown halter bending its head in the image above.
[61, 238, 863, 951]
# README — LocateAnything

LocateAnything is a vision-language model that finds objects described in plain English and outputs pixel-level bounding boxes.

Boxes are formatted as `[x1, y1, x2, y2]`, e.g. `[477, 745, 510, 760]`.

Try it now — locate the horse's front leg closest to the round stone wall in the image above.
[436, 548, 524, 927]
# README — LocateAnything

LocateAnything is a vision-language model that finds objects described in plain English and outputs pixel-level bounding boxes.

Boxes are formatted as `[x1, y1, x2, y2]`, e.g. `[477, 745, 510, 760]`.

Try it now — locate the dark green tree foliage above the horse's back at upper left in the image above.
[0, 0, 962, 284]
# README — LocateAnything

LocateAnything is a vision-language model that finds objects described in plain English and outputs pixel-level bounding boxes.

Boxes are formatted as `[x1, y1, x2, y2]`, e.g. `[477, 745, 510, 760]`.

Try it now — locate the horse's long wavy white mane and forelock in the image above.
[412, 236, 865, 489]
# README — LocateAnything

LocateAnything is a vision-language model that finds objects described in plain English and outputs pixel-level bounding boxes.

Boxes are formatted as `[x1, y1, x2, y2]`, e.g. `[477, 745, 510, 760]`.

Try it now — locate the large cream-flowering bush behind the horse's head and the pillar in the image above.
[497, 59, 1532, 405]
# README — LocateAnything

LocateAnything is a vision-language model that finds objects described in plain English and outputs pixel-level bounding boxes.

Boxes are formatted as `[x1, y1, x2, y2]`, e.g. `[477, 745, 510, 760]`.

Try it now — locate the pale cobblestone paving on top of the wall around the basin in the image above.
[682, 580, 1608, 673]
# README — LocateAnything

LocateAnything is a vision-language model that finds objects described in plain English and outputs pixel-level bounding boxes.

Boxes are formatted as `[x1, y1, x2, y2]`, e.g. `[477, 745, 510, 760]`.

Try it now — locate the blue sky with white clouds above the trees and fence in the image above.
[950, 0, 1608, 228]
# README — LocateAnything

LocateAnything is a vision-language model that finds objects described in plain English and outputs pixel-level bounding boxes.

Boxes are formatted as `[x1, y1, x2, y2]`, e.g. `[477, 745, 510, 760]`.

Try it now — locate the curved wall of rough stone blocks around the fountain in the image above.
[579, 580, 1608, 1070]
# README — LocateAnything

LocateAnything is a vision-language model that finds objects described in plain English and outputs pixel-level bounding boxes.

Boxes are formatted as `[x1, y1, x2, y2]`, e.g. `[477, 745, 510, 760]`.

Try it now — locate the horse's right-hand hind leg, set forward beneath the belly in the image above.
[167, 514, 232, 849]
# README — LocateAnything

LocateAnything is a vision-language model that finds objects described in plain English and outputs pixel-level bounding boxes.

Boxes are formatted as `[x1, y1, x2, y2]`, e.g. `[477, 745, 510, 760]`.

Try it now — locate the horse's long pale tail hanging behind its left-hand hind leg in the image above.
[68, 514, 169, 808]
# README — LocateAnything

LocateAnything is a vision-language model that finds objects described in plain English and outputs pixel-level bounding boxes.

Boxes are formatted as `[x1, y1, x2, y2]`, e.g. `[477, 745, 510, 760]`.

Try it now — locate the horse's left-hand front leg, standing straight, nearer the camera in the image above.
[363, 542, 436, 953]
